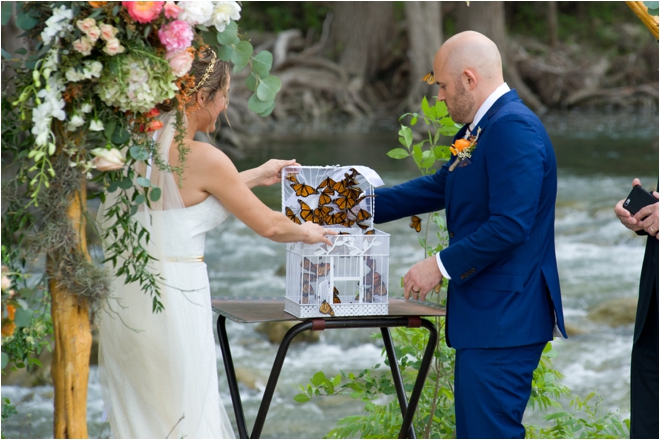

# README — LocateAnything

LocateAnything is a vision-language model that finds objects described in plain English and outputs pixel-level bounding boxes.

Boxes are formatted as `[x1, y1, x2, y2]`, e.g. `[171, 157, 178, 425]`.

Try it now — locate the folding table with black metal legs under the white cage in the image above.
[212, 297, 445, 438]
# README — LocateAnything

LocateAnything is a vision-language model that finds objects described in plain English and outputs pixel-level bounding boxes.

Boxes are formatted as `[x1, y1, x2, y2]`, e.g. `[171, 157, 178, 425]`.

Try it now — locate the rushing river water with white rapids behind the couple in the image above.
[2, 109, 658, 438]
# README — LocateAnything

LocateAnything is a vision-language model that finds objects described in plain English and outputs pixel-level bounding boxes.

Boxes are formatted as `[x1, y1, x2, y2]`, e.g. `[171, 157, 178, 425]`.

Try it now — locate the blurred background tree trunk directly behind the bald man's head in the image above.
[456, 1, 546, 112]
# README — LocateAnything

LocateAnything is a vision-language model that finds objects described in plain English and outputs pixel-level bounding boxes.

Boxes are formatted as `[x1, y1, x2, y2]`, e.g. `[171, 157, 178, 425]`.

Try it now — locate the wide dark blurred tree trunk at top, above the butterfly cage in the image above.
[329, 2, 396, 80]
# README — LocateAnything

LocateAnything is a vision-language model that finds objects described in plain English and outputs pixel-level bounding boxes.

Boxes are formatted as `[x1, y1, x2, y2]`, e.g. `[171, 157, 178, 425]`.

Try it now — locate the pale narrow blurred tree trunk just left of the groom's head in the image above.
[404, 2, 442, 109]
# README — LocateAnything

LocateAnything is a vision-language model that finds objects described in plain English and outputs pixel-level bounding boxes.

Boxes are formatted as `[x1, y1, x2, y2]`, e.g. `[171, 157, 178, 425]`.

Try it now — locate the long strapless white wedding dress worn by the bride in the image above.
[99, 112, 234, 439]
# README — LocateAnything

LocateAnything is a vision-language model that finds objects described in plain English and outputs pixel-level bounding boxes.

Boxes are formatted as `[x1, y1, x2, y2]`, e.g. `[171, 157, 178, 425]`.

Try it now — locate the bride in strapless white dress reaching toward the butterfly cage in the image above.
[99, 49, 331, 439]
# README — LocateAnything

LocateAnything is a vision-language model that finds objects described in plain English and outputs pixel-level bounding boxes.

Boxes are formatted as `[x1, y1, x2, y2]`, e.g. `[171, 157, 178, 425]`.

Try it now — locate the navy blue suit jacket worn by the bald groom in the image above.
[374, 90, 566, 348]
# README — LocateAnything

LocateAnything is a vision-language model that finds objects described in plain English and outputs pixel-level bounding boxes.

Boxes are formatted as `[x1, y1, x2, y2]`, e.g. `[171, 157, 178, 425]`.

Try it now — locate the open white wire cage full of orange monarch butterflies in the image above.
[282, 166, 390, 318]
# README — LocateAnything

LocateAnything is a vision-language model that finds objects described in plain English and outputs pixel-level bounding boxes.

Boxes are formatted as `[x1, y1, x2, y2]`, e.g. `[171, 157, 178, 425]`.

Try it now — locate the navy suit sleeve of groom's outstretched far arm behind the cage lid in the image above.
[374, 164, 449, 223]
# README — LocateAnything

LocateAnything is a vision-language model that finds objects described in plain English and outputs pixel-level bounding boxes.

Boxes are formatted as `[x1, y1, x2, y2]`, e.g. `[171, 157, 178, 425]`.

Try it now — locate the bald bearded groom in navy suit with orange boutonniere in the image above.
[375, 31, 566, 438]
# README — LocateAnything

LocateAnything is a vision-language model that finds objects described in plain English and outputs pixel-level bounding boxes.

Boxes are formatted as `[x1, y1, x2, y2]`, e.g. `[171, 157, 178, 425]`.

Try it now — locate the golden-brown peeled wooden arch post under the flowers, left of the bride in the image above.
[47, 181, 92, 438]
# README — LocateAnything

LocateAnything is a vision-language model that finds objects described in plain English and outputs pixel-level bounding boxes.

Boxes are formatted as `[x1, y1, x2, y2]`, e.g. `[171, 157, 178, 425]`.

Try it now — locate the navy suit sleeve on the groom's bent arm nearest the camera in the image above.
[440, 114, 554, 284]
